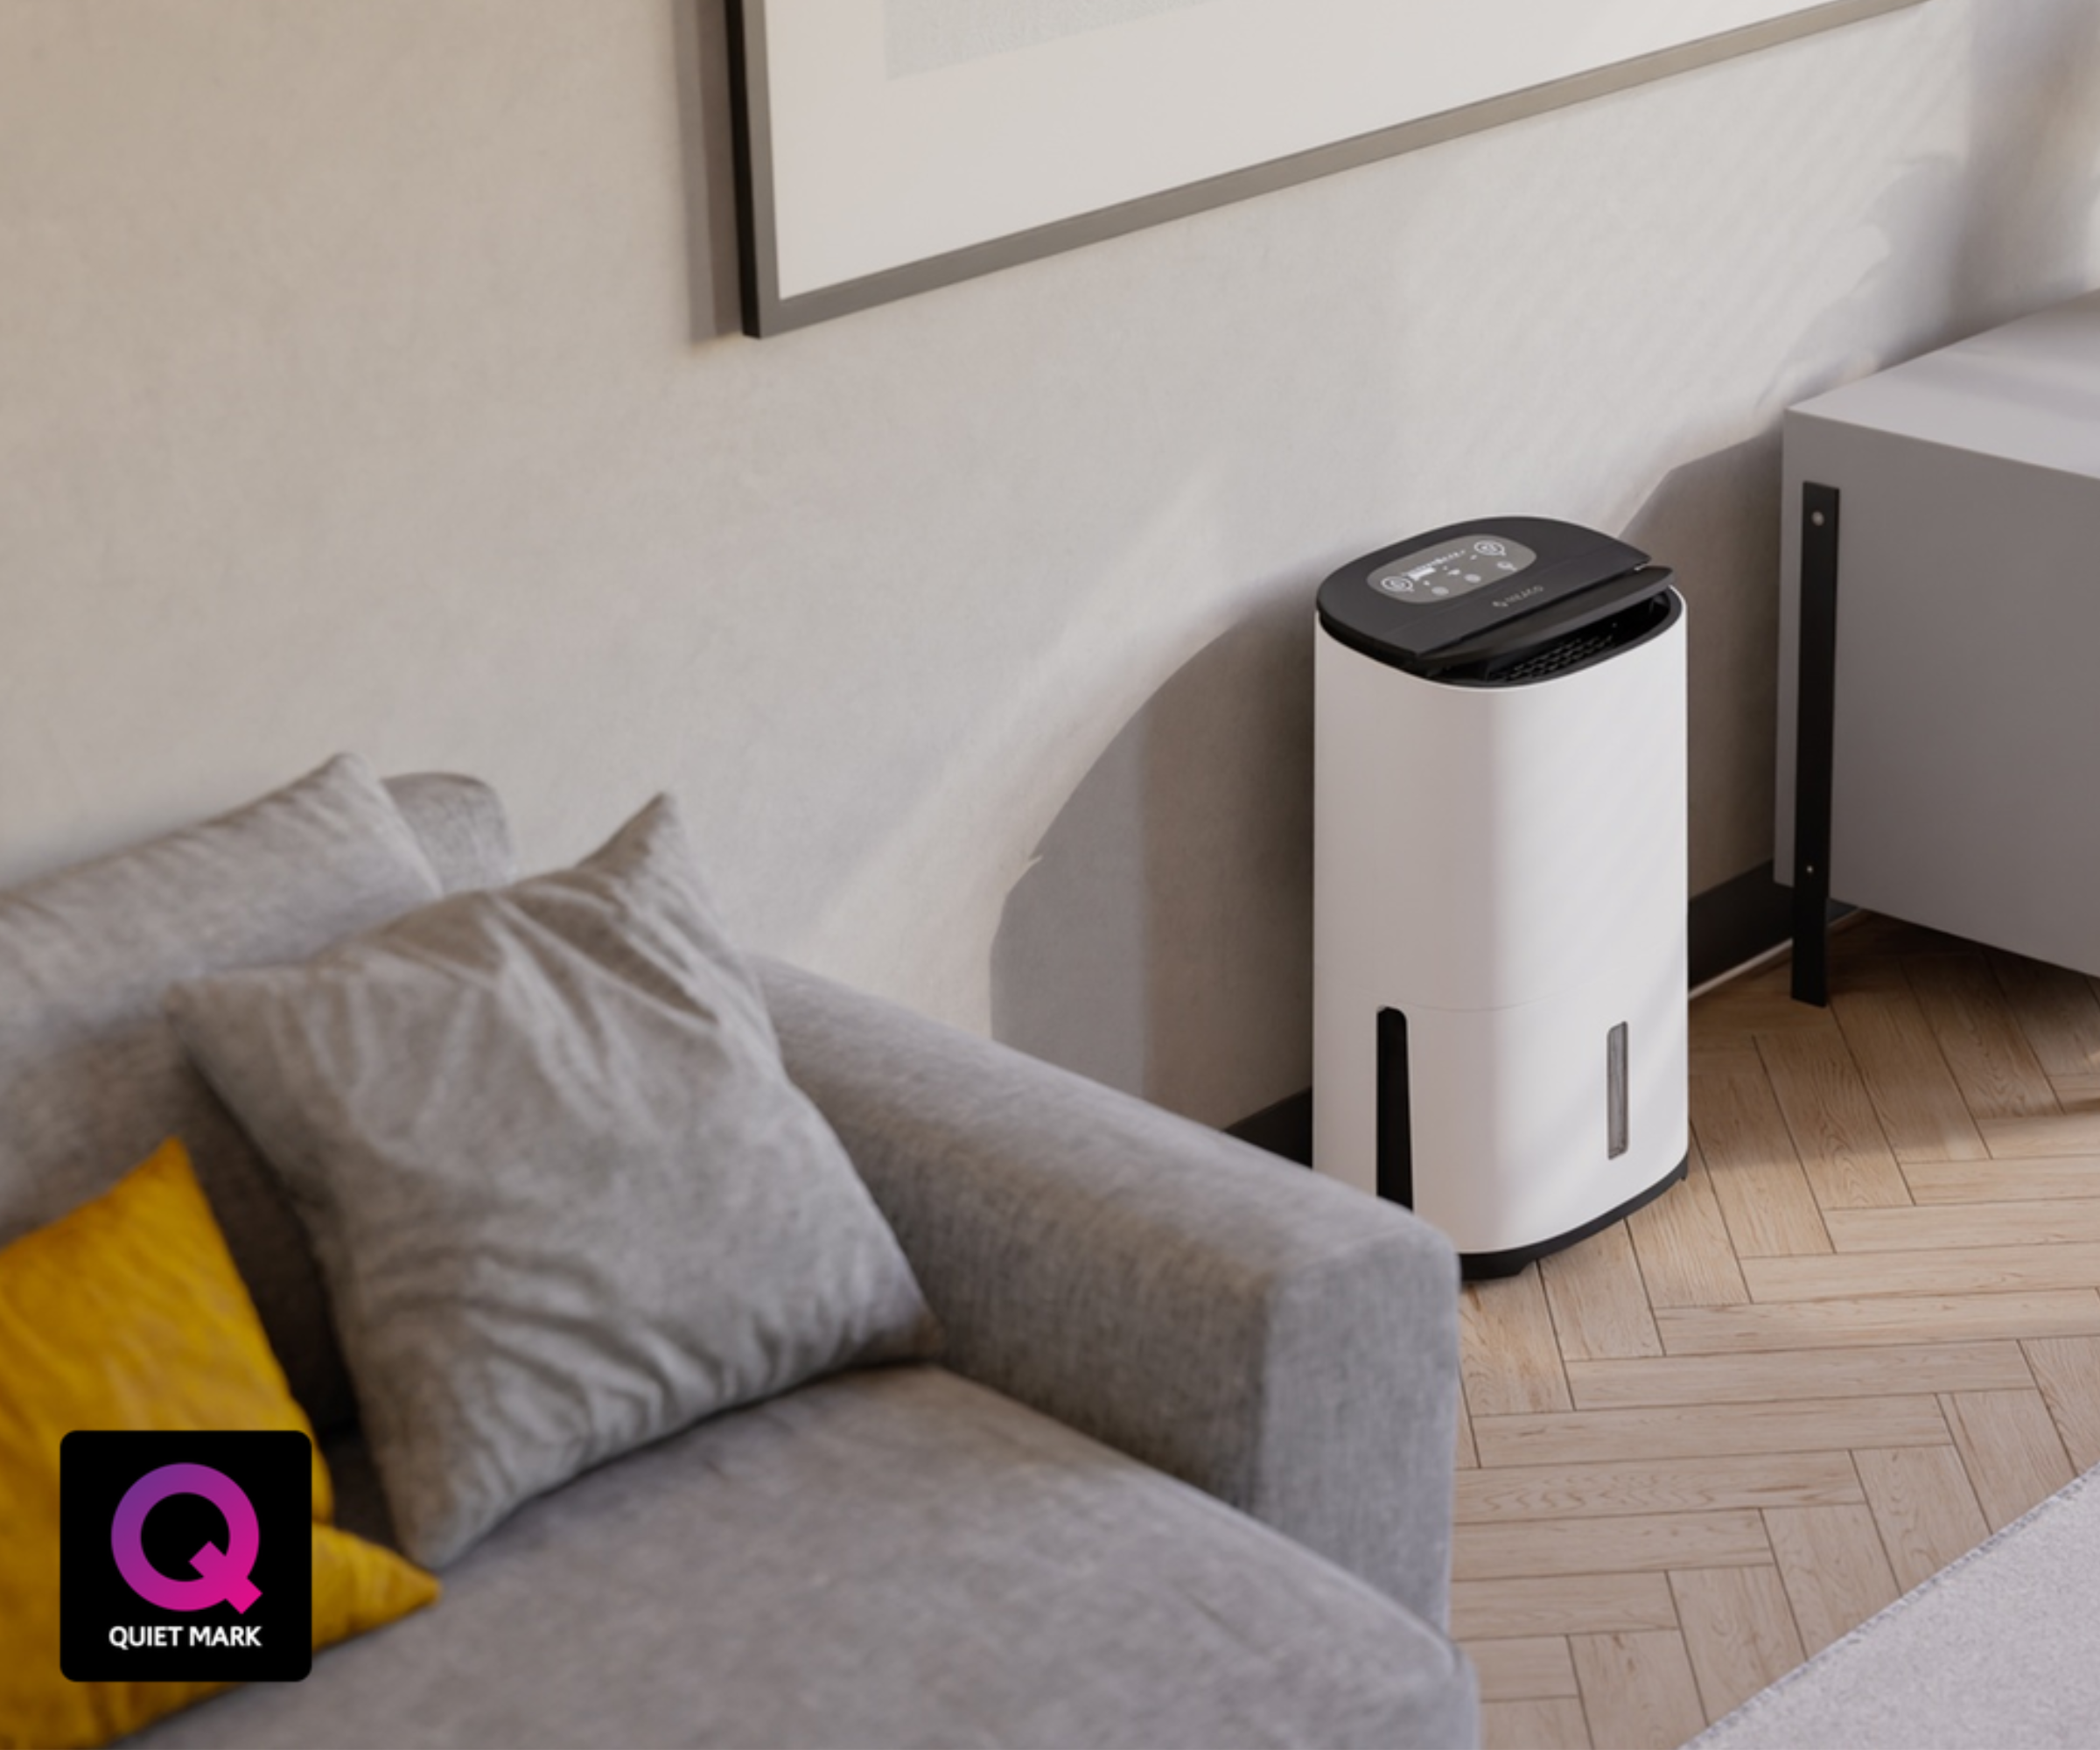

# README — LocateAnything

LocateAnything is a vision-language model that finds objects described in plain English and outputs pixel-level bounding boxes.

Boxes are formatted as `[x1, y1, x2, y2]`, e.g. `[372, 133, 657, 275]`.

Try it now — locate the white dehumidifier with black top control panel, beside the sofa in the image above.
[1312, 517, 1689, 1278]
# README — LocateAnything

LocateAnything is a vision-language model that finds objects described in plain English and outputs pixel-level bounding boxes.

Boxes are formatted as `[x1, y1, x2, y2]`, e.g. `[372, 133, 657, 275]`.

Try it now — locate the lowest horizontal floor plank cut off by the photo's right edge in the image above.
[1655, 1288, 2100, 1355]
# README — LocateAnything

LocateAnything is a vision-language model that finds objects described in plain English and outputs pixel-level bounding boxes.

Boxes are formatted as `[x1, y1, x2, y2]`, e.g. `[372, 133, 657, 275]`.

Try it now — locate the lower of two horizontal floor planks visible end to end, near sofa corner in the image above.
[1472, 1397, 1949, 1468]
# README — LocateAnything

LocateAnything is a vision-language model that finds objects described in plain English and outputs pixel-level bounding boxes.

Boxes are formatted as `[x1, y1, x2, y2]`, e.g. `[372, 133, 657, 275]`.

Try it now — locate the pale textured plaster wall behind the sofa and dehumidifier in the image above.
[0, 0, 2100, 1120]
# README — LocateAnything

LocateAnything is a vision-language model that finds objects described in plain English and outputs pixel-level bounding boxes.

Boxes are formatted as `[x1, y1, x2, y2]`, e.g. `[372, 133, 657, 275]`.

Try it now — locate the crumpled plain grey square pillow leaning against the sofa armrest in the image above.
[170, 798, 933, 1567]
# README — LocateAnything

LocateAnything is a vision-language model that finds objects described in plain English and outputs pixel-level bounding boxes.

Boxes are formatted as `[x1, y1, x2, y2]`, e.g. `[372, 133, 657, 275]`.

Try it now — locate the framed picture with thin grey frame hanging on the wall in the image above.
[729, 0, 1917, 334]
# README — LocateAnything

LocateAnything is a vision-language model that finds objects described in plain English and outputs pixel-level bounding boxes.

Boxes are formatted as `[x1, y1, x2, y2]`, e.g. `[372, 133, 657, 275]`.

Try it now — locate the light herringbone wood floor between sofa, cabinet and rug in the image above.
[1453, 918, 2100, 1750]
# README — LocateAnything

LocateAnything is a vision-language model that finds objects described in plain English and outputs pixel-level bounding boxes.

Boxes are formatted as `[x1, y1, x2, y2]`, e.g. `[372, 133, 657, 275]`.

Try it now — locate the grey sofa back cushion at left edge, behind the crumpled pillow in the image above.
[0, 756, 439, 1429]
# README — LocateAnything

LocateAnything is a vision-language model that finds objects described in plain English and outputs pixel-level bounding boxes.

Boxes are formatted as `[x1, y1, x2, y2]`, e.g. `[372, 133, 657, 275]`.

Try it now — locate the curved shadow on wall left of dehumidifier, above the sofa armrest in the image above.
[991, 594, 1312, 1124]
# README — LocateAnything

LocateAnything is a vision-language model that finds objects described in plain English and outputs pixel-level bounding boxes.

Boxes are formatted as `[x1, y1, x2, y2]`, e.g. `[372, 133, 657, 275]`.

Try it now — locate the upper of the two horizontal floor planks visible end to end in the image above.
[1569, 1340, 2033, 1410]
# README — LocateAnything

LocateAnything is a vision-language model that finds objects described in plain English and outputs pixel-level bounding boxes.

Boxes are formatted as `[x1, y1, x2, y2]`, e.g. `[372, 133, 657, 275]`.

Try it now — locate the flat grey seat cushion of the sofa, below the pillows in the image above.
[135, 1368, 1476, 1750]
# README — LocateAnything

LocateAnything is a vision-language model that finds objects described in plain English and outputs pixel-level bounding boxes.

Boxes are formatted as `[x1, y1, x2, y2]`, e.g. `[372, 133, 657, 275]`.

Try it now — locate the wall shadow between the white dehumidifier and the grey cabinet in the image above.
[1626, 430, 1779, 892]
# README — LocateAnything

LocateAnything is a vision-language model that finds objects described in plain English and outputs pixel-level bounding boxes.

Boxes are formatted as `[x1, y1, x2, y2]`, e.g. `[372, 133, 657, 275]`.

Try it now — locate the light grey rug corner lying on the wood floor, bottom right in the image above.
[1686, 1468, 2100, 1750]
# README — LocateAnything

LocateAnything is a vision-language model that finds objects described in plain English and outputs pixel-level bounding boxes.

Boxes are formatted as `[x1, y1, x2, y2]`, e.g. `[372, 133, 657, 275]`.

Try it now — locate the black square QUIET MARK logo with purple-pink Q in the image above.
[59, 1432, 313, 1683]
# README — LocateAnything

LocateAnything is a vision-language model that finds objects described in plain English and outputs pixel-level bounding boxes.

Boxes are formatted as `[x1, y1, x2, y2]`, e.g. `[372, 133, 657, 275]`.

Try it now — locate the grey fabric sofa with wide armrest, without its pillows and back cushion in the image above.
[0, 777, 1476, 1746]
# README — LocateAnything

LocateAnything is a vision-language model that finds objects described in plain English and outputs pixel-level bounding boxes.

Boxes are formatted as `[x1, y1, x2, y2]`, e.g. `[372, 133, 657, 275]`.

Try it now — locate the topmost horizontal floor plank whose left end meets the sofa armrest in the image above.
[1455, 1450, 1867, 1525]
